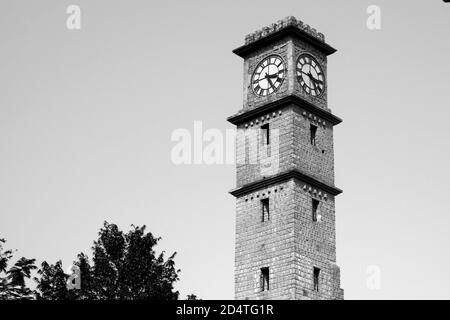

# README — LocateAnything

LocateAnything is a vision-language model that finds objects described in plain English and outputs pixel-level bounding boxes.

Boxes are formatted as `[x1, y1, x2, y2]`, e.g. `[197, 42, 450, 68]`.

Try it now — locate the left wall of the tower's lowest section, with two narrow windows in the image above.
[235, 180, 296, 299]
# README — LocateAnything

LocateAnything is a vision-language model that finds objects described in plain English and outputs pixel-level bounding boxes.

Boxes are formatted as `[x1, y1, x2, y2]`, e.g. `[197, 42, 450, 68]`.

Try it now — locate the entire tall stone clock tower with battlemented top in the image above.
[228, 17, 343, 299]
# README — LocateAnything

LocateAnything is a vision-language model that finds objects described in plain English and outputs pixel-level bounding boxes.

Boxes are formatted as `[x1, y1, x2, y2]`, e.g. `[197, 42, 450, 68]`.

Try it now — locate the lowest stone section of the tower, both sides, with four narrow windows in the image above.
[235, 179, 343, 299]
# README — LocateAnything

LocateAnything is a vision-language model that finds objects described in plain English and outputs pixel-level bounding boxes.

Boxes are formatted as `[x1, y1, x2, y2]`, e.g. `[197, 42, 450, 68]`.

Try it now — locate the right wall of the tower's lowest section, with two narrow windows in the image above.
[294, 181, 340, 300]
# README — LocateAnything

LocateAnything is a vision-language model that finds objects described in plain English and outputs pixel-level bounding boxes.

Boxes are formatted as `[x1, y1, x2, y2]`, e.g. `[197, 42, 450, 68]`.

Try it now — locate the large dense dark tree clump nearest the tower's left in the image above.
[35, 221, 180, 300]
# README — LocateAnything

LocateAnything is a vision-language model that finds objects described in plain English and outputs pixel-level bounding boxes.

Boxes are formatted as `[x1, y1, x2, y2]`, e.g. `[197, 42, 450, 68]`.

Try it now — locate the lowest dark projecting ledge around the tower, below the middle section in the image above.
[230, 170, 342, 197]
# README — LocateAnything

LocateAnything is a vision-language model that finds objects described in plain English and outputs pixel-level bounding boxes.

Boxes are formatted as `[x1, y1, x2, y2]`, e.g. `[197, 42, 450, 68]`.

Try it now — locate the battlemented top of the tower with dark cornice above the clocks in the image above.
[233, 17, 336, 58]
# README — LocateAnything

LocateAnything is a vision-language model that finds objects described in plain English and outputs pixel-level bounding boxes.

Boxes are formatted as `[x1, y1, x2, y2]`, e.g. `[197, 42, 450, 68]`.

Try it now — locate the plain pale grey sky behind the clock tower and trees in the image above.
[0, 0, 450, 299]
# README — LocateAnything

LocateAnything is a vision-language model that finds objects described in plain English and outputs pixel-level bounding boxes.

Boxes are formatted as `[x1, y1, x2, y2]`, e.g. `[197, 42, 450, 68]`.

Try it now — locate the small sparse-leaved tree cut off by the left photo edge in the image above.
[0, 239, 37, 300]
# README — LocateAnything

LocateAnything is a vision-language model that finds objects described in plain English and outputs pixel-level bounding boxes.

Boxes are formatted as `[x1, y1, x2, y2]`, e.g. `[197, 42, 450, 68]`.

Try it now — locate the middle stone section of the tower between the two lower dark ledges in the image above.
[236, 106, 334, 188]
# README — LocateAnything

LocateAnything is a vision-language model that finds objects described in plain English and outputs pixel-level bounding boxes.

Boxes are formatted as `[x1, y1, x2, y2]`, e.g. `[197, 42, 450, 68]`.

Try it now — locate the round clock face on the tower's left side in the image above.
[252, 56, 286, 96]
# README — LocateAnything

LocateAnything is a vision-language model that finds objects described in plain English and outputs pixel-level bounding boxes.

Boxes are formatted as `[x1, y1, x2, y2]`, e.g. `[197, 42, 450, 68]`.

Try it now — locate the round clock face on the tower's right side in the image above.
[297, 54, 325, 96]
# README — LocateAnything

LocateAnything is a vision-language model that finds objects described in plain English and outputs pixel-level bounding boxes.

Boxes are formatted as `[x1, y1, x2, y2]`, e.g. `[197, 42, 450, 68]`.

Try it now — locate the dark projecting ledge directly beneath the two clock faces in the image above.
[227, 95, 342, 125]
